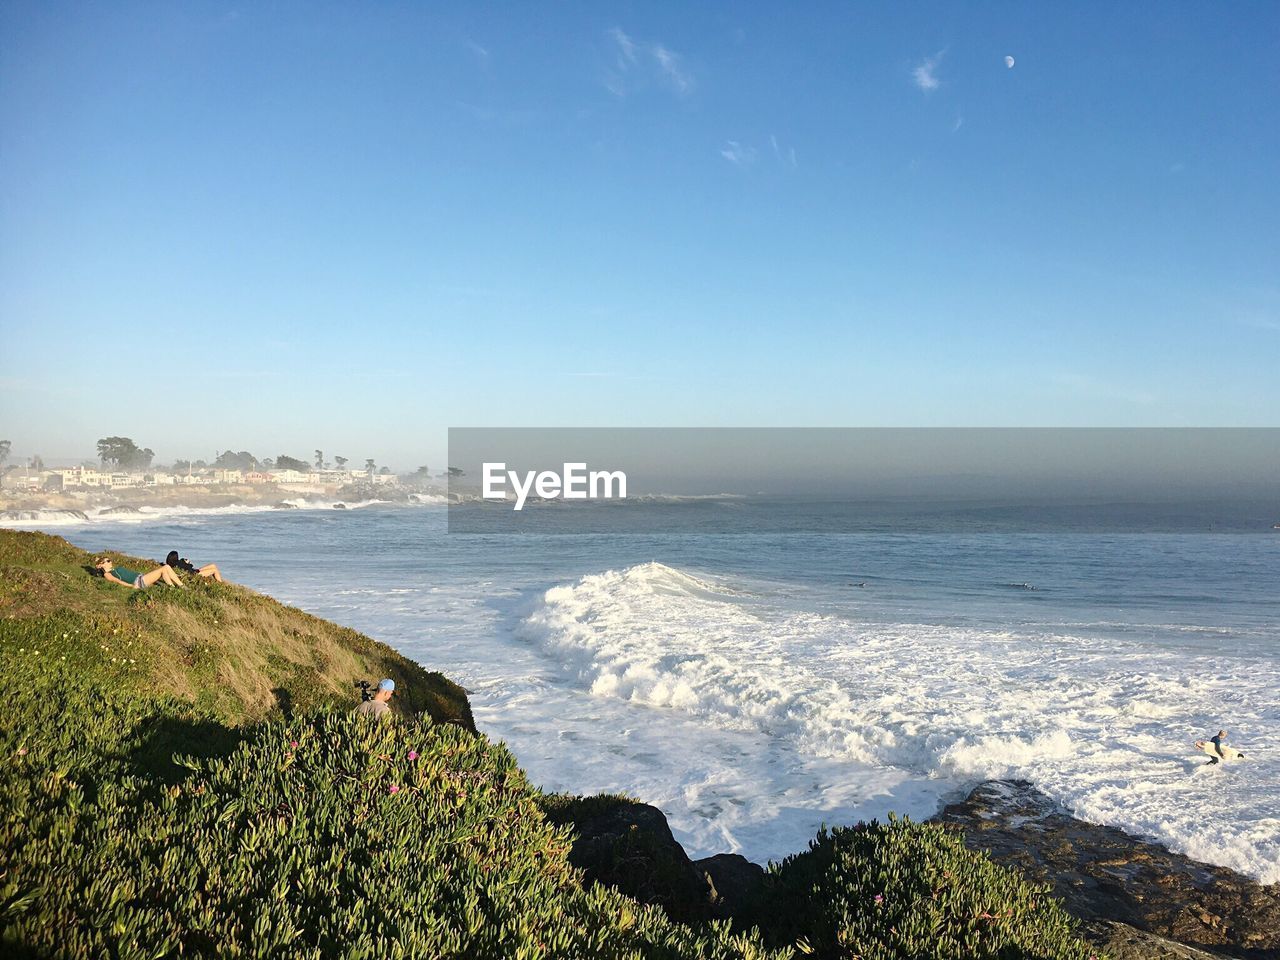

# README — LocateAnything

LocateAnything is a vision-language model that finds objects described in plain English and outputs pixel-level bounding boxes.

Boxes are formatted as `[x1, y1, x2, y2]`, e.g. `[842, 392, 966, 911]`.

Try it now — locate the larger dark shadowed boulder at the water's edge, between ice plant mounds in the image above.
[568, 803, 716, 923]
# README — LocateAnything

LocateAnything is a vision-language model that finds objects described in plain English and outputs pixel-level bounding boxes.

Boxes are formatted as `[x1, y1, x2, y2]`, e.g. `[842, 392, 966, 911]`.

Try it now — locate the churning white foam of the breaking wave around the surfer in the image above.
[521, 563, 1280, 882]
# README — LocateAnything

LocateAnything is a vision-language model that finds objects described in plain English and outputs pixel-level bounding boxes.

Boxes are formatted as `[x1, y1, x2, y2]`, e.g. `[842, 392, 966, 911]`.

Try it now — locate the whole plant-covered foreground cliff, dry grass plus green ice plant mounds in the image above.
[0, 531, 1091, 960]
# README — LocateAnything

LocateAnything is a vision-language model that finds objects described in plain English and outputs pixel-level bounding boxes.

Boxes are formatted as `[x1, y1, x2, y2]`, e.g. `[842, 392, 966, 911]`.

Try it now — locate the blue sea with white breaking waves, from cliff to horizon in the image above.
[6, 497, 1280, 882]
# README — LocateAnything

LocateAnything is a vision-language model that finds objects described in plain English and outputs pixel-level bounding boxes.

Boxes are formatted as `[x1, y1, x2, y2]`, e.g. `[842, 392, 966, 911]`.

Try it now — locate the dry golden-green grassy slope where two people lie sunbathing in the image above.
[0, 530, 475, 730]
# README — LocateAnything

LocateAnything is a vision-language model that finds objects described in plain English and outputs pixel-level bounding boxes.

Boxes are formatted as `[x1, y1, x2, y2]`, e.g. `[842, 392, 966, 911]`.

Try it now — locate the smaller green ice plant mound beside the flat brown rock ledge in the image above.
[762, 815, 1097, 960]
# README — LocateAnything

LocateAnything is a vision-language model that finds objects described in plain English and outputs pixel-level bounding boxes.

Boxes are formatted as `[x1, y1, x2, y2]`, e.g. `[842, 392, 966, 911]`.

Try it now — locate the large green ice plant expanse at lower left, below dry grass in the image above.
[0, 640, 787, 960]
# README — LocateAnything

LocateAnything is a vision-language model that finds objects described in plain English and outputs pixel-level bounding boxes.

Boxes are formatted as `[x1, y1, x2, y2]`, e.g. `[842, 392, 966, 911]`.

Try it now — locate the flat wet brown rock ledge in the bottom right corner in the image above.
[934, 781, 1280, 960]
